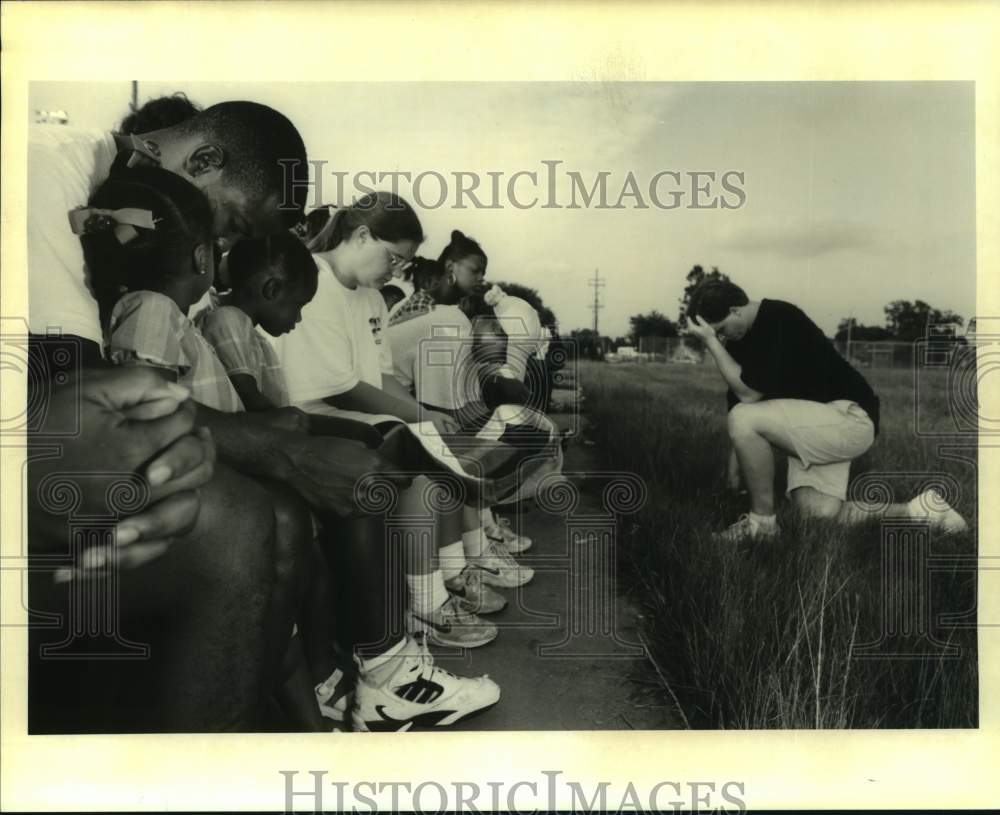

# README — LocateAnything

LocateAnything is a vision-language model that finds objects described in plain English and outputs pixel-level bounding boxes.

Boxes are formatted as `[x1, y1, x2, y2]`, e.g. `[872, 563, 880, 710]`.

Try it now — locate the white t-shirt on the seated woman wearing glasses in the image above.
[274, 255, 392, 405]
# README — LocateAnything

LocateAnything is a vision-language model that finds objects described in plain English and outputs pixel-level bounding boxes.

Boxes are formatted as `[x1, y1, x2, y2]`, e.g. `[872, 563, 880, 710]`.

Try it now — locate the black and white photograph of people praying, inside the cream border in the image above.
[0, 4, 1000, 811]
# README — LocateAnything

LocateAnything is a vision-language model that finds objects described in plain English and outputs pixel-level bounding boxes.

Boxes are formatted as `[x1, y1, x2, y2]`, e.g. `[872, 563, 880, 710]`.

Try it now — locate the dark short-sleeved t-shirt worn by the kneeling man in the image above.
[726, 300, 879, 433]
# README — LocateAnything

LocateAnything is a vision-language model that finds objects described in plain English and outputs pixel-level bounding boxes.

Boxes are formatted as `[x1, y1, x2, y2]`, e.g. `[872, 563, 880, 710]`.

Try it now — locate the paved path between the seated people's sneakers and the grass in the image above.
[435, 414, 678, 730]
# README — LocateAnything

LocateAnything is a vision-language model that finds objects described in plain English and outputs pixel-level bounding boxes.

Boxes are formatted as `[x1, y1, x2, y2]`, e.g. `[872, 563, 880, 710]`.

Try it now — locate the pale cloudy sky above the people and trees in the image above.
[31, 81, 976, 336]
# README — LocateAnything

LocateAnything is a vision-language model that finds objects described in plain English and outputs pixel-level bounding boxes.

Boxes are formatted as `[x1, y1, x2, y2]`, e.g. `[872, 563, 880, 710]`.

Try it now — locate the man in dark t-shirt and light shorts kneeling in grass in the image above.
[688, 280, 966, 542]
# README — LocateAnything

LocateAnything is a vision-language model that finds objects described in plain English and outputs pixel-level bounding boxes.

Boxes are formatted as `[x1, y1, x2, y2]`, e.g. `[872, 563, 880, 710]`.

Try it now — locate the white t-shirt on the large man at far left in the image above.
[28, 125, 118, 345]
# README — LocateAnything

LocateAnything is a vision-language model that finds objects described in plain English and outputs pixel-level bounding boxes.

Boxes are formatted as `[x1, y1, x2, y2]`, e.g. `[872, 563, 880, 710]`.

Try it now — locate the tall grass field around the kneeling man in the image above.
[579, 363, 978, 728]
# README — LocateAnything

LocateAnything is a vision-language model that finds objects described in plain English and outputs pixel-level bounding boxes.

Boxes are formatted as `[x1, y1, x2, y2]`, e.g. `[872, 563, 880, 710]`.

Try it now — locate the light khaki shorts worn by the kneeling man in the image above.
[765, 399, 875, 501]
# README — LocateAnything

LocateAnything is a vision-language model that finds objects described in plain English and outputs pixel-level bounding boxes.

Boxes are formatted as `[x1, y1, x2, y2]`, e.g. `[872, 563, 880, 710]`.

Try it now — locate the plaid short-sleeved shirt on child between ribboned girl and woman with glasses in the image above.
[195, 306, 288, 407]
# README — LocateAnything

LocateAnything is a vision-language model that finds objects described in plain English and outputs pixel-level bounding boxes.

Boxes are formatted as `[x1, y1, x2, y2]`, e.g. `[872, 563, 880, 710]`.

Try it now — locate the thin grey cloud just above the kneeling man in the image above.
[718, 220, 879, 258]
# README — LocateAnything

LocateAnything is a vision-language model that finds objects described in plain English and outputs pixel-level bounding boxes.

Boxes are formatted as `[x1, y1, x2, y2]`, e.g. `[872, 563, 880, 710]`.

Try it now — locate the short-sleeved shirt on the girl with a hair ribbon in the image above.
[108, 291, 243, 413]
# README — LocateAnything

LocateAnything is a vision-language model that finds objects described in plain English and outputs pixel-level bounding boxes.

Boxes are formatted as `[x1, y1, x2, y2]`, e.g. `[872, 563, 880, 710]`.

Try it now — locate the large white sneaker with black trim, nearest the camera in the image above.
[351, 637, 500, 732]
